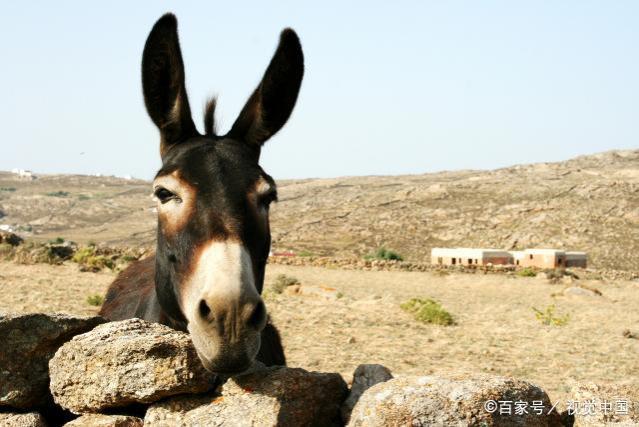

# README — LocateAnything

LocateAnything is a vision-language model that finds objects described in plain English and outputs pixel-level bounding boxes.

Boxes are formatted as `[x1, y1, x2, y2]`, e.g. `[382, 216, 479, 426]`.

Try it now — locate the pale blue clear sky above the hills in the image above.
[0, 0, 639, 179]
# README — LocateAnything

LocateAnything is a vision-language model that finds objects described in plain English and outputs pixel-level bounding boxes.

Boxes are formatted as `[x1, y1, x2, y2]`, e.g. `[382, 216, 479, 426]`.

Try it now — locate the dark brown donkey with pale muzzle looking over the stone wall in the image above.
[100, 14, 304, 374]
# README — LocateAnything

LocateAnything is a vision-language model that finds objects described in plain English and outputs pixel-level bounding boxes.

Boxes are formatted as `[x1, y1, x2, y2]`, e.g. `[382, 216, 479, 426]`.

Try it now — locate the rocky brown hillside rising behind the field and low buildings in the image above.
[0, 150, 639, 270]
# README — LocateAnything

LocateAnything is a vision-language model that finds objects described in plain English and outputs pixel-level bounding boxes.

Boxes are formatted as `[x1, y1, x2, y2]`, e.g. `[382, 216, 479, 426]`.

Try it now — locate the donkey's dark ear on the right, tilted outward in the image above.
[229, 28, 304, 148]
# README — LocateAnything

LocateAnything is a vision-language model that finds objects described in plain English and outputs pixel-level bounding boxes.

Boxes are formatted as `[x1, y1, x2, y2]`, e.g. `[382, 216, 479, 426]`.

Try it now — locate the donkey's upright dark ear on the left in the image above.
[142, 13, 197, 156]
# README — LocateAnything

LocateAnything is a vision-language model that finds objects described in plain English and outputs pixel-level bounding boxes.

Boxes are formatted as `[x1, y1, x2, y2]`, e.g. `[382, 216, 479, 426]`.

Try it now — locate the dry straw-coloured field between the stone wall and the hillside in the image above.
[0, 262, 639, 402]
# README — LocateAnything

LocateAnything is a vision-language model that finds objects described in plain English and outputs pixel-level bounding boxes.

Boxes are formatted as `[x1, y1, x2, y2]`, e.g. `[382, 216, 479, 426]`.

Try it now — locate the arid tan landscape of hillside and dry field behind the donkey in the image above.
[0, 151, 639, 408]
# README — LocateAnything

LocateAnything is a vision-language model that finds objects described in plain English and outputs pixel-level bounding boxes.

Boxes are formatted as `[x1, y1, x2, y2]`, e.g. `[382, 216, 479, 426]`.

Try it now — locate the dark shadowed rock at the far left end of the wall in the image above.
[0, 313, 106, 409]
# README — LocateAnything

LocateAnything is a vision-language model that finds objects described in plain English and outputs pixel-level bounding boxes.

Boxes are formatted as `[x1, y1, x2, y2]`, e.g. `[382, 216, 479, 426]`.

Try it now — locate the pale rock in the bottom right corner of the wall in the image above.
[567, 383, 639, 427]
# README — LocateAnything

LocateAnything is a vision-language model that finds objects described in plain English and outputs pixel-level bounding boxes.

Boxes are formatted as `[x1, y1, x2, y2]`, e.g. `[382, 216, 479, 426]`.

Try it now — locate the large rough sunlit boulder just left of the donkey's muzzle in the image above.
[49, 319, 215, 414]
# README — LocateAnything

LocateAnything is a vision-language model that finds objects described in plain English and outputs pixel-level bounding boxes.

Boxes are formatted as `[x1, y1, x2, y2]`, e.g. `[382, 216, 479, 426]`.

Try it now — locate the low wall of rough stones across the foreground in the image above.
[0, 314, 639, 427]
